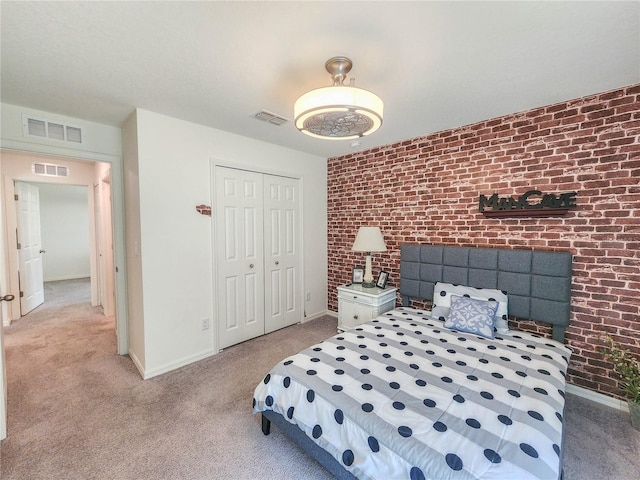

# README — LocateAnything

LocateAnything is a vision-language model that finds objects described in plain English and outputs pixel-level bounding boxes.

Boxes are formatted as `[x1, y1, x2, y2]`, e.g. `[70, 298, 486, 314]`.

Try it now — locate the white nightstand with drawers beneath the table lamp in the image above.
[338, 284, 398, 331]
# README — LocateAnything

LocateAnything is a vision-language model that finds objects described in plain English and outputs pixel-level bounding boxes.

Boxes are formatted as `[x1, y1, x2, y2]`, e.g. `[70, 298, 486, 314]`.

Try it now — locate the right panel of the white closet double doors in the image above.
[264, 175, 303, 333]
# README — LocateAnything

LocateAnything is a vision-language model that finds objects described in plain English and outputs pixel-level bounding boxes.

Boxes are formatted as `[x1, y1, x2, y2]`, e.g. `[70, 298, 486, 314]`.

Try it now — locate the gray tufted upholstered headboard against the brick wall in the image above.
[400, 244, 573, 342]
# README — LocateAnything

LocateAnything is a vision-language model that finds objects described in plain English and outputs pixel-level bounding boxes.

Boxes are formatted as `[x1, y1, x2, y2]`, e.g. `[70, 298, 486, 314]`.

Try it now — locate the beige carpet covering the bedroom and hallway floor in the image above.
[0, 281, 640, 480]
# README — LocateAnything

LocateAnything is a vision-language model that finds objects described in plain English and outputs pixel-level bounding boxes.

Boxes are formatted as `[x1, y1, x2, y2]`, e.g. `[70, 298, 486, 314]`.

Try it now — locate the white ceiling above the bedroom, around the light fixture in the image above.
[0, 0, 640, 157]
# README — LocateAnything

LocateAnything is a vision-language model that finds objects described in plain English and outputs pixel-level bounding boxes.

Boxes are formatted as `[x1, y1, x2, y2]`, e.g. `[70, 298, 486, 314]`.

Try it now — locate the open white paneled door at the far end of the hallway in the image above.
[16, 182, 44, 315]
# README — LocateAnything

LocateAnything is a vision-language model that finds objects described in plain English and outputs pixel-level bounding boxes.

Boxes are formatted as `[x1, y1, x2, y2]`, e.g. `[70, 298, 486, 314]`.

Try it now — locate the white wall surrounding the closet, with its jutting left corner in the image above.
[123, 109, 327, 378]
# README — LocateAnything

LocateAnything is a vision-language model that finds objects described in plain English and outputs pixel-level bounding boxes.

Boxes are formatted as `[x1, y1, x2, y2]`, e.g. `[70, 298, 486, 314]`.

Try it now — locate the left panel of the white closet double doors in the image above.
[214, 167, 264, 348]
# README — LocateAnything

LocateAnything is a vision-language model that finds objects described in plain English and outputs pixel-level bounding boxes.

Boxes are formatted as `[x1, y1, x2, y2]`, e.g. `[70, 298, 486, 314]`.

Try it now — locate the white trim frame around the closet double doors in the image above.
[209, 157, 307, 352]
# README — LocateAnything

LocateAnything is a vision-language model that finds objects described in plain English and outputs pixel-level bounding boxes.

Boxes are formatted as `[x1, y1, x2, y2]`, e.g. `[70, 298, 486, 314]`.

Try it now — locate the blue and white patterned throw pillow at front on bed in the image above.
[444, 295, 498, 339]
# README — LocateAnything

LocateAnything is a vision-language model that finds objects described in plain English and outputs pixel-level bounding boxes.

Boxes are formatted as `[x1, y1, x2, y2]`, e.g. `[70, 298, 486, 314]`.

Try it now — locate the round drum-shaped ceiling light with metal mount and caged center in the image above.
[293, 57, 383, 140]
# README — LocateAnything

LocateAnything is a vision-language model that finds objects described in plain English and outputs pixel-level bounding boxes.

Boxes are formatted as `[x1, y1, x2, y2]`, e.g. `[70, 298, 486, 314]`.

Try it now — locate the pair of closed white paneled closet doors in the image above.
[214, 167, 303, 348]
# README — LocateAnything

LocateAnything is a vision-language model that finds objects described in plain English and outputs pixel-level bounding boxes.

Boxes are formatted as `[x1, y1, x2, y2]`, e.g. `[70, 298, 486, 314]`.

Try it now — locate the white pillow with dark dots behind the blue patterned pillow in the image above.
[431, 282, 509, 334]
